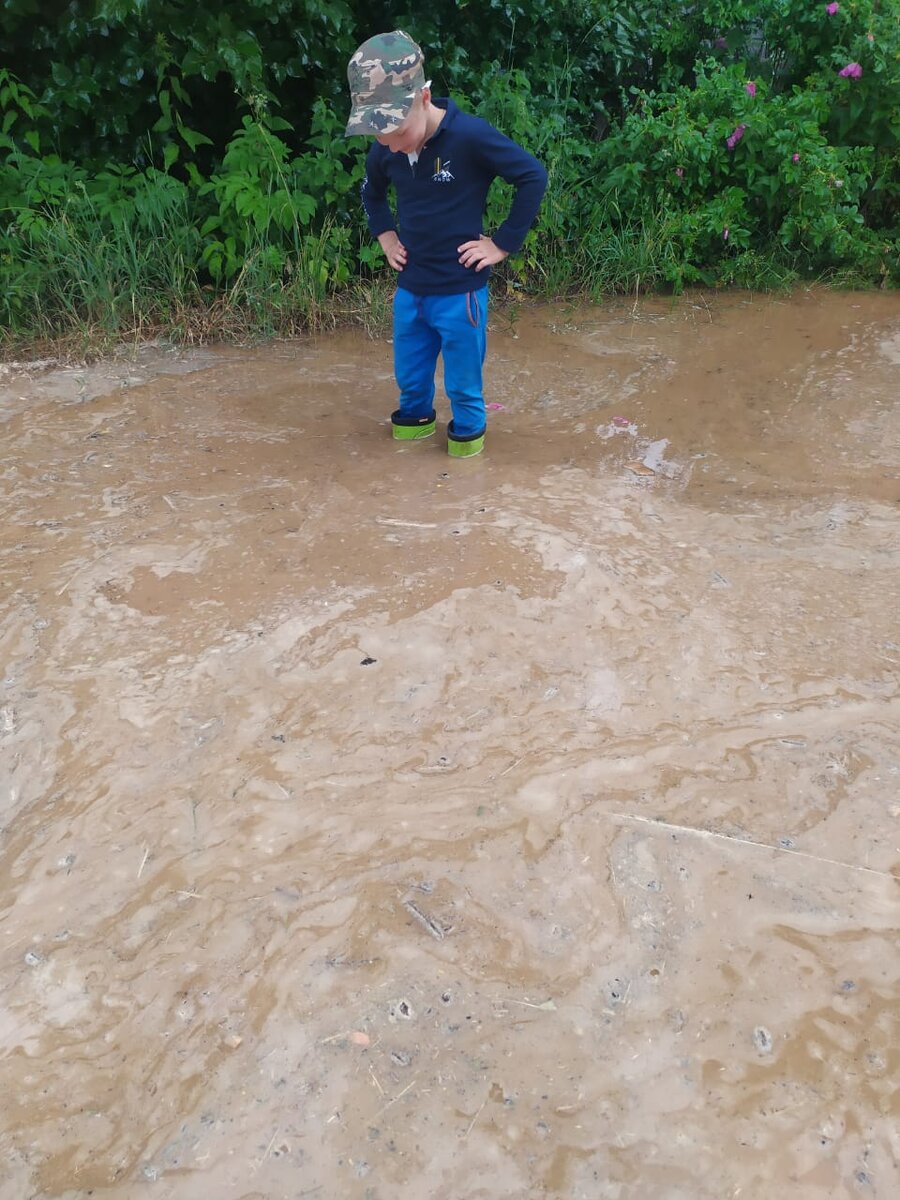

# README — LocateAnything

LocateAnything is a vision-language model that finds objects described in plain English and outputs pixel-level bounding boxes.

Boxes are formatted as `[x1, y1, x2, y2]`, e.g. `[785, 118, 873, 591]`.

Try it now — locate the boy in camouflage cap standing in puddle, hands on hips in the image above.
[347, 30, 547, 458]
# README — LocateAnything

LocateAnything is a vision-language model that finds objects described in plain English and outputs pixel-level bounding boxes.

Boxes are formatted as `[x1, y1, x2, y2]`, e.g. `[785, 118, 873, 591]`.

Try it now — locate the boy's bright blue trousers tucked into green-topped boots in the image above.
[394, 284, 487, 439]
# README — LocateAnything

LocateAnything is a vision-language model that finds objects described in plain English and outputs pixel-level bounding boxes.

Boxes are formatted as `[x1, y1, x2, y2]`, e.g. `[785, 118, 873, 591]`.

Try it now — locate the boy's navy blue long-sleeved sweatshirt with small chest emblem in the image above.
[362, 100, 547, 295]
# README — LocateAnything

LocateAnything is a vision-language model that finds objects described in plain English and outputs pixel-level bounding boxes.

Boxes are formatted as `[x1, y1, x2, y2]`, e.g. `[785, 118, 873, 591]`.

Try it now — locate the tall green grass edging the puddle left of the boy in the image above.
[0, 189, 385, 356]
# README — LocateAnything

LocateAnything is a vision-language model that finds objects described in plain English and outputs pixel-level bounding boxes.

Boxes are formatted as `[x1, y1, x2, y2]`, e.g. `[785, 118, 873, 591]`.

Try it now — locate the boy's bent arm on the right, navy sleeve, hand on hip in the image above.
[458, 121, 547, 271]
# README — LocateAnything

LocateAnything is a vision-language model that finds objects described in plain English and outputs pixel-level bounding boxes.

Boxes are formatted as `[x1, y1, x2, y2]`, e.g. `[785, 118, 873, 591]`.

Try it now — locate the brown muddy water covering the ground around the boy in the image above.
[0, 293, 900, 1200]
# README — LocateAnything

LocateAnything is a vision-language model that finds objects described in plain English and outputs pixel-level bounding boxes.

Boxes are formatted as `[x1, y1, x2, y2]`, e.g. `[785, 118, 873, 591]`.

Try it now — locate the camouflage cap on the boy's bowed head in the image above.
[346, 29, 425, 137]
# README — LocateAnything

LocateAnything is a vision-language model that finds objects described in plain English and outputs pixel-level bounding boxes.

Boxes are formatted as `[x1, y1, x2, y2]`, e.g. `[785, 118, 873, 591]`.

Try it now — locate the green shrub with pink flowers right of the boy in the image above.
[588, 60, 889, 287]
